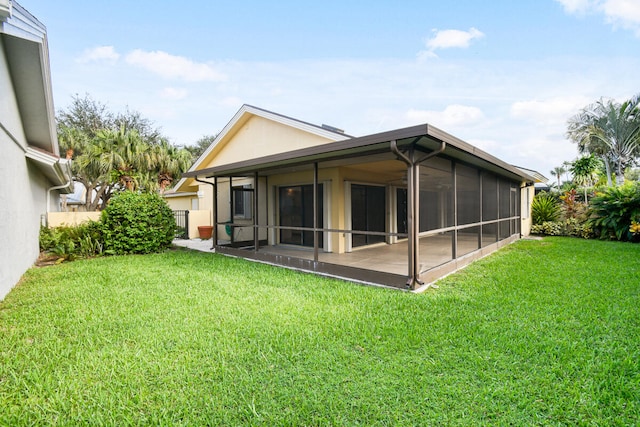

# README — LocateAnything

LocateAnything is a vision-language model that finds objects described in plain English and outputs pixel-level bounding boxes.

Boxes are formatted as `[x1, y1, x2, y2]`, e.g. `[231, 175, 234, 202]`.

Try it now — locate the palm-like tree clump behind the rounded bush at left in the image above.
[58, 95, 191, 211]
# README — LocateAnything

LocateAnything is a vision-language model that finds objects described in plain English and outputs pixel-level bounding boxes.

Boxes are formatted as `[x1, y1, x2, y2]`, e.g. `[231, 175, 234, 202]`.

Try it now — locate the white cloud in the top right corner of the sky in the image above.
[556, 0, 640, 37]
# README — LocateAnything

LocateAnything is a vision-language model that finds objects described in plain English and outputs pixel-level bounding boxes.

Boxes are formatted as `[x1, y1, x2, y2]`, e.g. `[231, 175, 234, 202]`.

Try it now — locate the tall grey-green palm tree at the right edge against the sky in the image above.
[567, 94, 640, 185]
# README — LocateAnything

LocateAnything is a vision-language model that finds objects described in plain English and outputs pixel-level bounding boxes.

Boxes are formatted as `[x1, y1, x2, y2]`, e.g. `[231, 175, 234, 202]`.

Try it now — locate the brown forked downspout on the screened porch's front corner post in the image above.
[390, 140, 447, 290]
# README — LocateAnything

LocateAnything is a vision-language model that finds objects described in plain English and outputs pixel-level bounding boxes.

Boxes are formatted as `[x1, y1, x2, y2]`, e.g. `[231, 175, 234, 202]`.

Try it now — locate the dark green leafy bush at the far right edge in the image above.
[588, 182, 640, 242]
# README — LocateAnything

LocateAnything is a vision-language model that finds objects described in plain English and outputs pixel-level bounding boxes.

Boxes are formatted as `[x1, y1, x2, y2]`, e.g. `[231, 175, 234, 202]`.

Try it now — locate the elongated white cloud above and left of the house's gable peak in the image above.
[126, 49, 226, 82]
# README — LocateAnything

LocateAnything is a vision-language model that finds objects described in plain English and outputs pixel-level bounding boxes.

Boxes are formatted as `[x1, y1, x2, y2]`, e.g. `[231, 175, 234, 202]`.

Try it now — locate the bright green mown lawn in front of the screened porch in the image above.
[0, 238, 640, 426]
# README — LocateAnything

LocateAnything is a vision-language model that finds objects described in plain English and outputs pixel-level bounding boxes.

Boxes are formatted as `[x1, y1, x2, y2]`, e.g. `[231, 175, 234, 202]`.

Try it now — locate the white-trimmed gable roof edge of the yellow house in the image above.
[173, 104, 352, 191]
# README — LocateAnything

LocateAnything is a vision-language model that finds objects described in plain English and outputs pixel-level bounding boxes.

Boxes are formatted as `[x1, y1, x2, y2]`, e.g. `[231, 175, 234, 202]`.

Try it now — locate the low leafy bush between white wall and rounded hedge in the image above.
[40, 221, 103, 261]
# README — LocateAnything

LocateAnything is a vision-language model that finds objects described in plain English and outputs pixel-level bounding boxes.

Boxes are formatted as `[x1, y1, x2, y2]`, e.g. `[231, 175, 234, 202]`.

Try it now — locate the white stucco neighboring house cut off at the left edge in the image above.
[0, 0, 73, 300]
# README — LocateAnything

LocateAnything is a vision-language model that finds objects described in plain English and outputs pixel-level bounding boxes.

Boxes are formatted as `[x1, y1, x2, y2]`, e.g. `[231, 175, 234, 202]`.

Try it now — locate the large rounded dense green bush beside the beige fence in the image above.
[101, 191, 176, 254]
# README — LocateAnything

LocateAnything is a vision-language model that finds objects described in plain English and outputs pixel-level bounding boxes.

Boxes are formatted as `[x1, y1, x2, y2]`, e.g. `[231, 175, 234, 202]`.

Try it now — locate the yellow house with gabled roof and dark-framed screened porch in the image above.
[174, 105, 537, 290]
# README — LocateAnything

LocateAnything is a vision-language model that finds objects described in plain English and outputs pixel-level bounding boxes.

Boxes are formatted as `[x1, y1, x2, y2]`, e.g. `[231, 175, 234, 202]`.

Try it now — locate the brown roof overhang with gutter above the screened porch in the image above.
[182, 124, 536, 183]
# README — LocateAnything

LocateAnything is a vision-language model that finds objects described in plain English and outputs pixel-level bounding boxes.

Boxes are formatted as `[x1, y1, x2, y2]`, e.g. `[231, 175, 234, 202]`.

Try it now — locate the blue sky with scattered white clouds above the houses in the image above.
[20, 0, 640, 177]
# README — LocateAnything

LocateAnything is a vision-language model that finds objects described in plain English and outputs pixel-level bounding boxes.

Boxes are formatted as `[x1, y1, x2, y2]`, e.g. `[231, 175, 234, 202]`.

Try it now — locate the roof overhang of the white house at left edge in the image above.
[0, 0, 59, 154]
